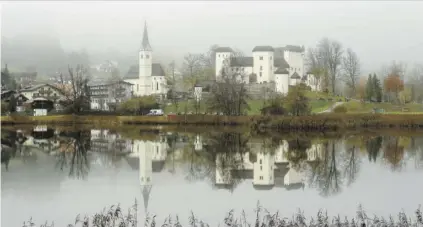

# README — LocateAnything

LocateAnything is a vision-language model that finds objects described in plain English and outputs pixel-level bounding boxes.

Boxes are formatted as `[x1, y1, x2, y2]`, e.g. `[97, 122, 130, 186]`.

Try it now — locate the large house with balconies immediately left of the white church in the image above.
[88, 80, 133, 111]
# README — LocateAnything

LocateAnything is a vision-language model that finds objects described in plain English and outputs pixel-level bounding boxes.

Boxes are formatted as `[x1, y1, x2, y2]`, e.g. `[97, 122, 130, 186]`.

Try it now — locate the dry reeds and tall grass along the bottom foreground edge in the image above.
[23, 201, 423, 227]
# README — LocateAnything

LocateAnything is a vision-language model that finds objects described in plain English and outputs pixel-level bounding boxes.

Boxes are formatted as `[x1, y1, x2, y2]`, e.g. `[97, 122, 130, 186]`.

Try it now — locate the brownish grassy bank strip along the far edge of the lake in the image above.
[1, 113, 423, 131]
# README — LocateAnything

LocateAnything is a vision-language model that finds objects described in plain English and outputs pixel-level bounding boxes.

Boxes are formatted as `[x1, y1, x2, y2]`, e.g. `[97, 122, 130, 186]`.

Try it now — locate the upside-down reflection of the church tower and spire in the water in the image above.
[138, 144, 153, 215]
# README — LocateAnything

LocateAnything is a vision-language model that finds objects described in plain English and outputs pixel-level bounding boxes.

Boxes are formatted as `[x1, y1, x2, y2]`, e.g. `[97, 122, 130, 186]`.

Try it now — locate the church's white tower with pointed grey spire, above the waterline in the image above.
[138, 22, 153, 96]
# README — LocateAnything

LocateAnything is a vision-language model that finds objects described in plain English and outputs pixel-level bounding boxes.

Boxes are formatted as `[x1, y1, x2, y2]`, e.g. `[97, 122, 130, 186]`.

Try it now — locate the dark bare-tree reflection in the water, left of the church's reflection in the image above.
[56, 131, 90, 179]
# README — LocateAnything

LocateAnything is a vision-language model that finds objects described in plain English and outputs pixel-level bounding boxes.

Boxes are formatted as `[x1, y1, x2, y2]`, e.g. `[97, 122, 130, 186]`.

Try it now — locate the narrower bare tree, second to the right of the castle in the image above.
[342, 48, 360, 96]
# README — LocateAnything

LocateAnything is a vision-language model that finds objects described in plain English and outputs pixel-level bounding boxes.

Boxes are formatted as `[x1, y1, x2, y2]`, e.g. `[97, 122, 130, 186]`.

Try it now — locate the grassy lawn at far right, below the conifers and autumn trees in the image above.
[344, 100, 423, 114]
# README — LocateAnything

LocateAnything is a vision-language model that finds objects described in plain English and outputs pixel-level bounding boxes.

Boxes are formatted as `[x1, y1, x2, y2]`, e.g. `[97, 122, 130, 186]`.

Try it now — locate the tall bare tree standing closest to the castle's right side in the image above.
[318, 38, 343, 93]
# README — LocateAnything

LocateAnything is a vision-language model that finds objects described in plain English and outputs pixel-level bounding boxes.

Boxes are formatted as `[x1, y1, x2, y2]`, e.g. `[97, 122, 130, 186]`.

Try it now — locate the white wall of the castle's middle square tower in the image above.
[253, 51, 275, 83]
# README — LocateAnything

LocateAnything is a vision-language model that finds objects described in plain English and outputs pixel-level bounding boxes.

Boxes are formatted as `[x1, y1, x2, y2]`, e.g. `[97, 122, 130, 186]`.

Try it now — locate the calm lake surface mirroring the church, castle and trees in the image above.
[1, 126, 423, 226]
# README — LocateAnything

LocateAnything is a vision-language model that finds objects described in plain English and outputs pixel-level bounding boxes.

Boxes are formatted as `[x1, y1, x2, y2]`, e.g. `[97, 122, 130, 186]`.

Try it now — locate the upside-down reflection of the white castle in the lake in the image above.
[215, 141, 323, 190]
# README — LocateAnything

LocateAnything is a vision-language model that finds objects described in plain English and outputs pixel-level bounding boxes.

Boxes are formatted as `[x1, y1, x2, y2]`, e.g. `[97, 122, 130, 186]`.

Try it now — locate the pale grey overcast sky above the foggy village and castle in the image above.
[2, 1, 423, 70]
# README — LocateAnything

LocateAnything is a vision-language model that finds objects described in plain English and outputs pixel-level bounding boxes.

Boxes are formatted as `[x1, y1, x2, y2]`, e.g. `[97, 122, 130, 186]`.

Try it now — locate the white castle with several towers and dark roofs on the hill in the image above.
[215, 45, 317, 94]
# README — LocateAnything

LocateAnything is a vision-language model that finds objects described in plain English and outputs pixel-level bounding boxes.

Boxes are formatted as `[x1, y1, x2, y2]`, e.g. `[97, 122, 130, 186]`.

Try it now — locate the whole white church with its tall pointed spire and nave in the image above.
[123, 23, 167, 98]
